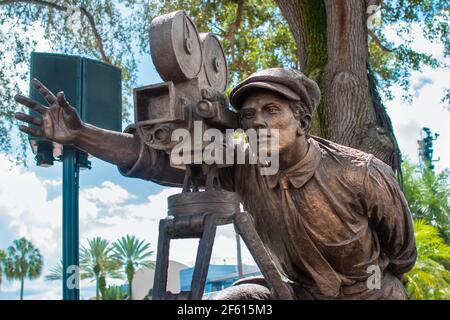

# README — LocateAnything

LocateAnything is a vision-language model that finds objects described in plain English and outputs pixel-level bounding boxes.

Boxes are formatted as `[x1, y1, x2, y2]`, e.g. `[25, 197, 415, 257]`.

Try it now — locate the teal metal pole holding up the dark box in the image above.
[62, 146, 80, 300]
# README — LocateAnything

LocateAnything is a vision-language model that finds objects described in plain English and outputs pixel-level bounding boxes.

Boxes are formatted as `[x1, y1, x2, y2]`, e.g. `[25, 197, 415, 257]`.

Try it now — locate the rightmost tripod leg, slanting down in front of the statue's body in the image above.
[234, 212, 295, 300]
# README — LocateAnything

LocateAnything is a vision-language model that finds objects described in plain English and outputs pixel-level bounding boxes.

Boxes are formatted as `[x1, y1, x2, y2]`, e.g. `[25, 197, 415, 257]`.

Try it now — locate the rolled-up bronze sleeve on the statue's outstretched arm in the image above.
[118, 125, 184, 187]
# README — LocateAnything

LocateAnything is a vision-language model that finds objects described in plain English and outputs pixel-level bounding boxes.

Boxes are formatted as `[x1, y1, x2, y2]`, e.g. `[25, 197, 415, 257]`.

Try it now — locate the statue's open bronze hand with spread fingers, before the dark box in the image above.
[15, 79, 83, 144]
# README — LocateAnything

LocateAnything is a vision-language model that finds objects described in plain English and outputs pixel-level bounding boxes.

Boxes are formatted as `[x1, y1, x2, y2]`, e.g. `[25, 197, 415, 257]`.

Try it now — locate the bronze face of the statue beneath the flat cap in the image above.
[240, 91, 299, 155]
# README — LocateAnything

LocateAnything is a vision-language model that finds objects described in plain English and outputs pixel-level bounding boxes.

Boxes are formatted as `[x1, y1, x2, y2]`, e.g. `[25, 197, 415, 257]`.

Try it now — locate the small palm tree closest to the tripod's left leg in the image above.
[113, 235, 154, 300]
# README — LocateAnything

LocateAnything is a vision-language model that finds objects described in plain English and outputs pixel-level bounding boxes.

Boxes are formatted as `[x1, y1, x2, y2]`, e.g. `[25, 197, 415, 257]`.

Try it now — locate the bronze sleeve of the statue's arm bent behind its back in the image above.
[364, 158, 417, 275]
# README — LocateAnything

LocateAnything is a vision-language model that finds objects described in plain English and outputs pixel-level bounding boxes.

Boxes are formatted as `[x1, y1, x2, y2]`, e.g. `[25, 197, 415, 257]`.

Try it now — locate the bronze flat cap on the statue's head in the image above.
[230, 68, 320, 114]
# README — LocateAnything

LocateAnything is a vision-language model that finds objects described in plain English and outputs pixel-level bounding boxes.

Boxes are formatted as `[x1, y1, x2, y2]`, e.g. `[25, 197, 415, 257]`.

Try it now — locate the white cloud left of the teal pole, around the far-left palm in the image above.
[0, 155, 61, 299]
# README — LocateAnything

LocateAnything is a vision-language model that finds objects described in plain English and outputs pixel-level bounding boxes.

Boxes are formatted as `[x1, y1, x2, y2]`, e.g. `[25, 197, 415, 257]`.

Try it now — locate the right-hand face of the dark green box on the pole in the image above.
[81, 59, 122, 131]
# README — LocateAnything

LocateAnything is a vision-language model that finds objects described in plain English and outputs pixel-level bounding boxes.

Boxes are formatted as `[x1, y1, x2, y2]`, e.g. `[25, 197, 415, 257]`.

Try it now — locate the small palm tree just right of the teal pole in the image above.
[80, 237, 122, 300]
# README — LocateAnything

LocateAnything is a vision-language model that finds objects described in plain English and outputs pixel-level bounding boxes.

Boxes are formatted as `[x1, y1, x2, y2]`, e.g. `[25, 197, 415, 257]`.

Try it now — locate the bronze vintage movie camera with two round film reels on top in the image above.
[134, 11, 238, 180]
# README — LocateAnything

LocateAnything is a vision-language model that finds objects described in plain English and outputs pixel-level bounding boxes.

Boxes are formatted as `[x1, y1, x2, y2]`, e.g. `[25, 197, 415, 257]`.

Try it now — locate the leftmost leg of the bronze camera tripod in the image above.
[152, 218, 172, 300]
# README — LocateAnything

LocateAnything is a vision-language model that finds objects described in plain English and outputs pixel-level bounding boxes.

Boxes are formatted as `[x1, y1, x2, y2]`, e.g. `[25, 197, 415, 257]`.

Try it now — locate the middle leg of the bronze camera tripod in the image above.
[190, 215, 217, 300]
